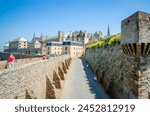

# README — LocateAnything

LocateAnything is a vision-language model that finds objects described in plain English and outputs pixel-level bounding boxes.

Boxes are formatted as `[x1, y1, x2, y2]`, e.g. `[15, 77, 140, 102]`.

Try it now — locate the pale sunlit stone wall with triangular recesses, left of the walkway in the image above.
[0, 56, 69, 99]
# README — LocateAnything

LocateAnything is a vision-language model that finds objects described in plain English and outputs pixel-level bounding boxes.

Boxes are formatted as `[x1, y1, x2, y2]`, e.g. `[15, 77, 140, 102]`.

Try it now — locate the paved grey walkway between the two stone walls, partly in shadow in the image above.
[61, 58, 108, 99]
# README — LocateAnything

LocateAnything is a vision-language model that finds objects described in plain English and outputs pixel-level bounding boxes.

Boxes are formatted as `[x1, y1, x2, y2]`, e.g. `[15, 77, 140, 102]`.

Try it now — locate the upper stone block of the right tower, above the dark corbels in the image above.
[121, 11, 150, 44]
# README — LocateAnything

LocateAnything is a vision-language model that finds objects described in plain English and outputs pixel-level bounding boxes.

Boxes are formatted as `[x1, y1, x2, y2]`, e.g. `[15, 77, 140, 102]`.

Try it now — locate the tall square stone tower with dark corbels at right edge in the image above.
[121, 11, 150, 98]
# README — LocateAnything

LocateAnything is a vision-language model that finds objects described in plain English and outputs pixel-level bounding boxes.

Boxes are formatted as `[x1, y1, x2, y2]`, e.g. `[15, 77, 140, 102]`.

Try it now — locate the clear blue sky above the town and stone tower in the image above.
[0, 0, 150, 51]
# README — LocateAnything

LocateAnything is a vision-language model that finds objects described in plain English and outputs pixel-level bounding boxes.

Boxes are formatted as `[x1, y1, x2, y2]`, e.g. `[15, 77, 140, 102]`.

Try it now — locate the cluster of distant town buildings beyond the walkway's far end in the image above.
[4, 31, 102, 57]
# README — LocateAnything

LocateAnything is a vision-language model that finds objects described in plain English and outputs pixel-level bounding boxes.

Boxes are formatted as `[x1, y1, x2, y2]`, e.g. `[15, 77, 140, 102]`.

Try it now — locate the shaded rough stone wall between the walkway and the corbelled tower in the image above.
[86, 46, 136, 99]
